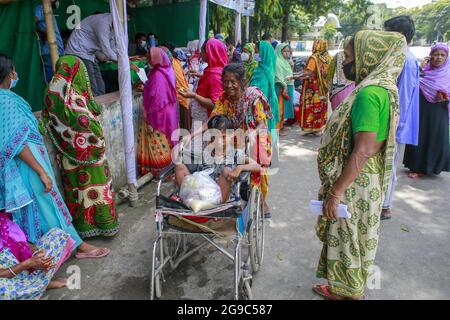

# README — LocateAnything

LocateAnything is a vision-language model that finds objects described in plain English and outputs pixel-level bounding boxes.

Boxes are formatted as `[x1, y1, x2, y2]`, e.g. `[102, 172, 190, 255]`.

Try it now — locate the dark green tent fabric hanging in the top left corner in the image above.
[0, 0, 45, 111]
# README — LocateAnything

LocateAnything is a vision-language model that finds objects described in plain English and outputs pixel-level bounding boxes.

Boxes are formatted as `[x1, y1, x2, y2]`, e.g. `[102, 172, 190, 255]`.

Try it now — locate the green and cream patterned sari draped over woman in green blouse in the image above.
[316, 31, 406, 298]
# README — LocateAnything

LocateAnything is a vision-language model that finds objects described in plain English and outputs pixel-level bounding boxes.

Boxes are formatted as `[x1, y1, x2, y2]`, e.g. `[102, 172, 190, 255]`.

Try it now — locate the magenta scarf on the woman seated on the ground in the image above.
[0, 211, 32, 262]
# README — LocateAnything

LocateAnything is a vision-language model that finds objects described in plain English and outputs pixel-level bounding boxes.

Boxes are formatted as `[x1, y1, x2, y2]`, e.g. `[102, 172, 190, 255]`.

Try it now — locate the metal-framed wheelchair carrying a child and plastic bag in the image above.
[150, 142, 264, 300]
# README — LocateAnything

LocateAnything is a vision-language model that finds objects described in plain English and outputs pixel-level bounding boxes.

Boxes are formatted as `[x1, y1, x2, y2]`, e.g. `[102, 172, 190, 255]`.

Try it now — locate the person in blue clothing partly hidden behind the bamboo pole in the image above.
[34, 0, 64, 84]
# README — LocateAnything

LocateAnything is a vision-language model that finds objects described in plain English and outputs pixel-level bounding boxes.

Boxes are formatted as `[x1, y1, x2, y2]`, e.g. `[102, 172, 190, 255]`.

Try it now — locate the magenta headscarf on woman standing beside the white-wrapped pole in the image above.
[144, 48, 178, 144]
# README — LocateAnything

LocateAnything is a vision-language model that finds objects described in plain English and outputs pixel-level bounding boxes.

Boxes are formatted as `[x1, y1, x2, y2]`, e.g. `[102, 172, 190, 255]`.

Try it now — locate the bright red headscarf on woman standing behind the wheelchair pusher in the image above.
[197, 38, 228, 109]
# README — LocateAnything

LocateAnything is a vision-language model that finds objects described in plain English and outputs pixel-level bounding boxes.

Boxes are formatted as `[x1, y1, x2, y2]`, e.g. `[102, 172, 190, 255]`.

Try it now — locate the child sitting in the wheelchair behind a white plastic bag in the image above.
[175, 115, 261, 203]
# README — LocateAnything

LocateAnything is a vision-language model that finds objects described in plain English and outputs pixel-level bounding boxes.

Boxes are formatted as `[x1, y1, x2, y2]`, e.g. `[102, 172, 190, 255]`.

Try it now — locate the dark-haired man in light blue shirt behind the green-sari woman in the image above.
[381, 16, 419, 220]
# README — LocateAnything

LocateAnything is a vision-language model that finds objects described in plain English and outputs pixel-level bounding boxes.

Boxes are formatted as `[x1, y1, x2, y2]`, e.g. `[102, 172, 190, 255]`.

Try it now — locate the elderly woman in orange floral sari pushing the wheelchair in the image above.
[183, 63, 276, 218]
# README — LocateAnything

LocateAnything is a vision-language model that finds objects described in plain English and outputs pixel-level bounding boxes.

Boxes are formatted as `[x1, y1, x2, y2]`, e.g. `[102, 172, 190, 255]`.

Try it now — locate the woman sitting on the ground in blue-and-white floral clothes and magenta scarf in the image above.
[0, 211, 75, 300]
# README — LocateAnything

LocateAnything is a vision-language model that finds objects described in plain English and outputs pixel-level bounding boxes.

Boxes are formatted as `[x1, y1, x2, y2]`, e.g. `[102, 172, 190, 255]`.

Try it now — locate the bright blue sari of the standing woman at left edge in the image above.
[0, 89, 82, 248]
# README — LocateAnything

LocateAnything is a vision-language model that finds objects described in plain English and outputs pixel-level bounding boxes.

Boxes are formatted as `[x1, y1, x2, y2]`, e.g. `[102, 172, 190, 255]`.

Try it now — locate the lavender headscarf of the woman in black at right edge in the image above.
[420, 42, 450, 103]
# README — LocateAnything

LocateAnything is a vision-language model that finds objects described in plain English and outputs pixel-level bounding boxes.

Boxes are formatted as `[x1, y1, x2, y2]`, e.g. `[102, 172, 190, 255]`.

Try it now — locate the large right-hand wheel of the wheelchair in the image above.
[248, 187, 264, 273]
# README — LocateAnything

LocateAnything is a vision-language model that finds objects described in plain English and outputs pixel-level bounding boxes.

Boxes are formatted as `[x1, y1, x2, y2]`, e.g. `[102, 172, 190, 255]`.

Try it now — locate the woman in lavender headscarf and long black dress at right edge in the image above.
[403, 43, 450, 178]
